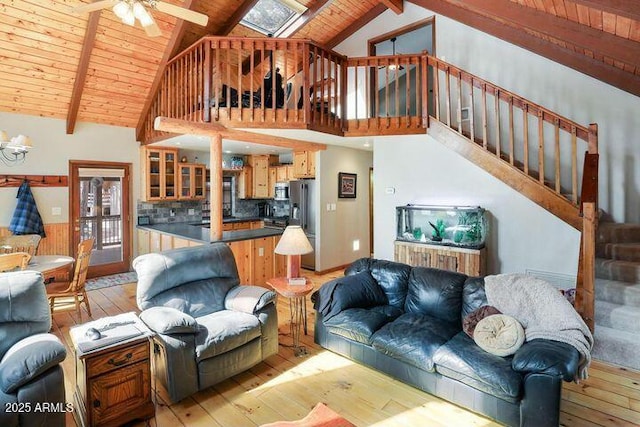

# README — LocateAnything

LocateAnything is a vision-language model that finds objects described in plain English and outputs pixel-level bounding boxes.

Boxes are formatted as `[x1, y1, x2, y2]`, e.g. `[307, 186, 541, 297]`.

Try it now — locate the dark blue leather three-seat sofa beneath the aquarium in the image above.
[312, 258, 579, 427]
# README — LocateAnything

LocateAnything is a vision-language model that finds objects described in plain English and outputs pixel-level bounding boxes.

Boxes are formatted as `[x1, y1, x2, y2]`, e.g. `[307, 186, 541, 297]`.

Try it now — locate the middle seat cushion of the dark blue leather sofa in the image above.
[371, 313, 460, 371]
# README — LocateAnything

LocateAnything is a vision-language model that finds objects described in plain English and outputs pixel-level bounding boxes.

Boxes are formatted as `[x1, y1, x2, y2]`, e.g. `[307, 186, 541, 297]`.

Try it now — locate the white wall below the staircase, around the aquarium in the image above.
[373, 135, 580, 276]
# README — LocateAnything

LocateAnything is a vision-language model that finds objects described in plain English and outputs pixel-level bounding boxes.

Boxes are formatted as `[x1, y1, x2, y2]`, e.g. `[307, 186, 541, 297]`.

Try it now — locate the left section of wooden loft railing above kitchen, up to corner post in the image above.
[143, 37, 346, 142]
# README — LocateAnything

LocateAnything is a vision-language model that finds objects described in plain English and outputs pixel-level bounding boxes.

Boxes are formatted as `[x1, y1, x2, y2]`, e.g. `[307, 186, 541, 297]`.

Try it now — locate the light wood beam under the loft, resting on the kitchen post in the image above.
[153, 117, 327, 151]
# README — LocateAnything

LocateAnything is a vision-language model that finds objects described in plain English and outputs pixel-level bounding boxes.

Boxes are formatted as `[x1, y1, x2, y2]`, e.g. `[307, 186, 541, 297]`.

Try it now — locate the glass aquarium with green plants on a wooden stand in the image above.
[396, 205, 487, 249]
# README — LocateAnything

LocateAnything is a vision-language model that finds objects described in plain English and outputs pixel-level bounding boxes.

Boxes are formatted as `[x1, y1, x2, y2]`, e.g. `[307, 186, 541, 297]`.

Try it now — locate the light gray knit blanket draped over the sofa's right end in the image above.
[485, 274, 593, 382]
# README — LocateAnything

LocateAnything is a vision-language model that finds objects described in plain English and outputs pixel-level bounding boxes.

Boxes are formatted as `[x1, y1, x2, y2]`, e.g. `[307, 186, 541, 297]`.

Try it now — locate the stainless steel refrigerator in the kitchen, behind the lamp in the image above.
[289, 179, 317, 271]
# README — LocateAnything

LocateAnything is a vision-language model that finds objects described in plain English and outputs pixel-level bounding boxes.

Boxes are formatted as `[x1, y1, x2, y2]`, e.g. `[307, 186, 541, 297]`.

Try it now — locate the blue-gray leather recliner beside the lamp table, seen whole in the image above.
[133, 243, 278, 402]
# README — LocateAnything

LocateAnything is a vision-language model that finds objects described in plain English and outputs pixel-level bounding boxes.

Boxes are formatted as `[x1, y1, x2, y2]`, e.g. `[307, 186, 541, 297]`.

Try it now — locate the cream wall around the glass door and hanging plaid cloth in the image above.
[0, 113, 140, 231]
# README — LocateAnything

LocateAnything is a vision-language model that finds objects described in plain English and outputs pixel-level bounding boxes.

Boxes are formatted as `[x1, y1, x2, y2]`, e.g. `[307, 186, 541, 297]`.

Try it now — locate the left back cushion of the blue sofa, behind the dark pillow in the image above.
[344, 258, 411, 309]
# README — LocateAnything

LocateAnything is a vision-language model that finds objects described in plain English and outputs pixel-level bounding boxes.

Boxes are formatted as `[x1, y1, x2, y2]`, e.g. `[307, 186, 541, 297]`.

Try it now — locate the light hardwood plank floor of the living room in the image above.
[53, 272, 640, 427]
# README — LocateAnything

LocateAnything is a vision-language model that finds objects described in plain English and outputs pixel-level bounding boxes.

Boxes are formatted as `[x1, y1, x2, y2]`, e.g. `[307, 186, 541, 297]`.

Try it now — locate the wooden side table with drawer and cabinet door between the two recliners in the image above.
[71, 313, 155, 427]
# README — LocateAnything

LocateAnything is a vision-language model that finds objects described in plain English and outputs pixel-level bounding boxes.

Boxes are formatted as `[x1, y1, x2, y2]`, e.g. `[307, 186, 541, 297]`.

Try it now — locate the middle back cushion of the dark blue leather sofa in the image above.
[404, 267, 467, 327]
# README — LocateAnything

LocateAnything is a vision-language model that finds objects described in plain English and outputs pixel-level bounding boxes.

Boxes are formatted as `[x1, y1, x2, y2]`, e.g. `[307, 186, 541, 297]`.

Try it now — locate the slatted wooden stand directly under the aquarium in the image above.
[394, 241, 487, 276]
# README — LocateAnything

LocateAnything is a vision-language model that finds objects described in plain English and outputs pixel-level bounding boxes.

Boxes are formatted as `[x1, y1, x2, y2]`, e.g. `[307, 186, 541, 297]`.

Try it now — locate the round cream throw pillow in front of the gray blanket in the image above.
[473, 314, 524, 357]
